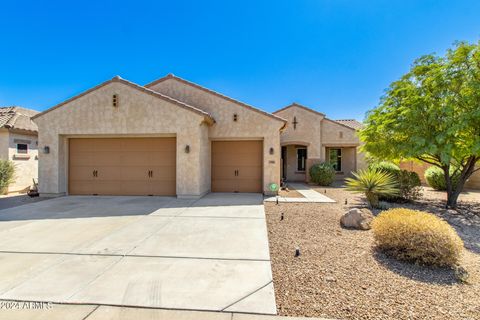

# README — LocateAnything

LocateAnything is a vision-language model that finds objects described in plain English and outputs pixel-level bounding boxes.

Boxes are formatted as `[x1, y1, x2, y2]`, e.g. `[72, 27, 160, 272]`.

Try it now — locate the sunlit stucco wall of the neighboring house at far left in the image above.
[0, 130, 38, 192]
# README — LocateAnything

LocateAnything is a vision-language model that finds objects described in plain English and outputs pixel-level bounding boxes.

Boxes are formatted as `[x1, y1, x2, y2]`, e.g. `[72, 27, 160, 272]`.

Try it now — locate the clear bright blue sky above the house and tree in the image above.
[0, 0, 480, 120]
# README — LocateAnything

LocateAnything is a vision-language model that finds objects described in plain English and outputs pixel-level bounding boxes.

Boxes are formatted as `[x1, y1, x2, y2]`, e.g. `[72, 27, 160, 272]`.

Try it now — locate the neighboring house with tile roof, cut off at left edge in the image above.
[0, 107, 38, 192]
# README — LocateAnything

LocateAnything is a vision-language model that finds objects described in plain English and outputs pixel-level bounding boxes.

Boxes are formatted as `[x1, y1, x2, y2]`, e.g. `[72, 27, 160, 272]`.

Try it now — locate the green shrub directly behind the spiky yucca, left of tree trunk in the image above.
[368, 161, 422, 201]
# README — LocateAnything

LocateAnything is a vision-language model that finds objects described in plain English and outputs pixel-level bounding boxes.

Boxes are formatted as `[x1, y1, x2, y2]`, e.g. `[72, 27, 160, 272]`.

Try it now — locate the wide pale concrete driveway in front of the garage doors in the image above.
[0, 194, 276, 314]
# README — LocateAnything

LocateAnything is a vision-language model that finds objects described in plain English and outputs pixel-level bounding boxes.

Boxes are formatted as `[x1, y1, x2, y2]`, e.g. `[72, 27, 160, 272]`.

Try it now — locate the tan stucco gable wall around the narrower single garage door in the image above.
[149, 79, 284, 193]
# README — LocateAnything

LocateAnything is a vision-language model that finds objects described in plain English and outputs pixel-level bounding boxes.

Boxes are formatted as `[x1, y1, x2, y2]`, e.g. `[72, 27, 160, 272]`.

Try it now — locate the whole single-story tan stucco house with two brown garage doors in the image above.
[33, 74, 366, 198]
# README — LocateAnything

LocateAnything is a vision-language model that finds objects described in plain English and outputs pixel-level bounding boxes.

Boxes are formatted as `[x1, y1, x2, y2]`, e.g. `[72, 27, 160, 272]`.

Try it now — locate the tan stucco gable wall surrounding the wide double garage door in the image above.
[34, 82, 209, 197]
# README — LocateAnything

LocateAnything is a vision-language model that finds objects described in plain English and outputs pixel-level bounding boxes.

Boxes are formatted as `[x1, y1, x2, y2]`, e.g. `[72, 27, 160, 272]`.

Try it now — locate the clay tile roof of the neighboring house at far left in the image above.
[0, 106, 38, 132]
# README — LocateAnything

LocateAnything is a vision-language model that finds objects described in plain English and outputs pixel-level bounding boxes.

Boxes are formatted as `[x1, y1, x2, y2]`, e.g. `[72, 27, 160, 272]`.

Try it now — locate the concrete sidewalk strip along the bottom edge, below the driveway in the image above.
[0, 301, 332, 320]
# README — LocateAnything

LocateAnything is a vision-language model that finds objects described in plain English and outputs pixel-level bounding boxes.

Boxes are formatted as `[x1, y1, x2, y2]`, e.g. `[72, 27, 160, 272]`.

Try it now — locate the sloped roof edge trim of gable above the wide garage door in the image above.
[32, 76, 215, 124]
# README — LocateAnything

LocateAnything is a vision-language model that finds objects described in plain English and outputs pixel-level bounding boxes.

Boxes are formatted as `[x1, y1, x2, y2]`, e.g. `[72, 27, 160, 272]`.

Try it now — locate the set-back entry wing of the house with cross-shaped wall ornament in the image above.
[274, 103, 365, 182]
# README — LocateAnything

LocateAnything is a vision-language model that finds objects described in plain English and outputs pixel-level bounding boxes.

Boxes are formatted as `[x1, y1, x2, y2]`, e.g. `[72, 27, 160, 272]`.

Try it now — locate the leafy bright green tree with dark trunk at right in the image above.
[360, 42, 480, 208]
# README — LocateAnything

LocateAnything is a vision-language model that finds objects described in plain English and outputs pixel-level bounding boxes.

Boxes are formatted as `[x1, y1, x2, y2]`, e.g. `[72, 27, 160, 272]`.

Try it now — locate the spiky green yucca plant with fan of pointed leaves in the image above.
[346, 169, 400, 208]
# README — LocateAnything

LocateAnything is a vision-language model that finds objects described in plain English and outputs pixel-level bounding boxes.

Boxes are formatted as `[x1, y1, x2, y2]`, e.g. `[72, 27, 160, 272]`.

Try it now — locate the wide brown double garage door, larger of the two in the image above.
[69, 138, 176, 195]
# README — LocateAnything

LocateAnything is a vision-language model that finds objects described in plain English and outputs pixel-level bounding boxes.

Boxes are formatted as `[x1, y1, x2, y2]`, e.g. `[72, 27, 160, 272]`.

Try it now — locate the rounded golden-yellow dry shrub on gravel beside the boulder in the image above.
[372, 208, 463, 267]
